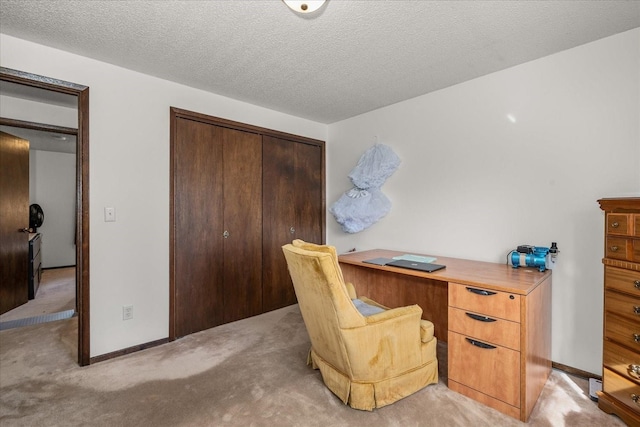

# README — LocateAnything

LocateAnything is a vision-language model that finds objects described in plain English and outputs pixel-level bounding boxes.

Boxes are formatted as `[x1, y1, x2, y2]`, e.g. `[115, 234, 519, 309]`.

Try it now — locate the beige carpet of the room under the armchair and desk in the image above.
[0, 305, 624, 427]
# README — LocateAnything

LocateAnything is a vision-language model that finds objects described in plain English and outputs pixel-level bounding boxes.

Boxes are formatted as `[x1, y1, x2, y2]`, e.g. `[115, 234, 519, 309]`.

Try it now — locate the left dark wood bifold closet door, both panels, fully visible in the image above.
[173, 118, 262, 337]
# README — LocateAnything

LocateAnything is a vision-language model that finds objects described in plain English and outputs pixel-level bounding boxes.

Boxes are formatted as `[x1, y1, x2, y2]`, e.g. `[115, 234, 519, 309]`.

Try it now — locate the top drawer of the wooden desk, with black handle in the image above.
[449, 283, 521, 322]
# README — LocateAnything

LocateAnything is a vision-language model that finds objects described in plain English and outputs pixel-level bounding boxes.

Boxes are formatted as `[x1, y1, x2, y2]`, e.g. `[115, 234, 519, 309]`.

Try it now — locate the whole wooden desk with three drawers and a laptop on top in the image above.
[339, 249, 551, 421]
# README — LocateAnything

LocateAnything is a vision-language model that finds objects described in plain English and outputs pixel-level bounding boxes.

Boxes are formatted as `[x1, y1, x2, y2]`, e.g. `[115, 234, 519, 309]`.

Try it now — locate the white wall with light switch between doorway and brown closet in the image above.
[0, 34, 327, 357]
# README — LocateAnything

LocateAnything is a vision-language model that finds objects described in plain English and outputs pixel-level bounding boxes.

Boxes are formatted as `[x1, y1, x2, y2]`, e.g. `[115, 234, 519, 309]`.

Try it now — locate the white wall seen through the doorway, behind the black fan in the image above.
[29, 150, 76, 268]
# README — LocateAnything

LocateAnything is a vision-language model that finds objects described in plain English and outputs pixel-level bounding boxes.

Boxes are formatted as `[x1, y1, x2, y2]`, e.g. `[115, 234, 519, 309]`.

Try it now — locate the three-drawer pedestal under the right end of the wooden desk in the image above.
[448, 277, 551, 421]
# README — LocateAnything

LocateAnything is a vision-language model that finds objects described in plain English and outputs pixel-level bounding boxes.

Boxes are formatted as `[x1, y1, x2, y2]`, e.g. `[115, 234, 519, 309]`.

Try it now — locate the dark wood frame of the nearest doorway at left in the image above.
[0, 67, 91, 366]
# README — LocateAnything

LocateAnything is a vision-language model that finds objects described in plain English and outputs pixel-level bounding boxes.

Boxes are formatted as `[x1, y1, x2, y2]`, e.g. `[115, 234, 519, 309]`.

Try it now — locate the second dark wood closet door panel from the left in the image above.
[218, 129, 262, 322]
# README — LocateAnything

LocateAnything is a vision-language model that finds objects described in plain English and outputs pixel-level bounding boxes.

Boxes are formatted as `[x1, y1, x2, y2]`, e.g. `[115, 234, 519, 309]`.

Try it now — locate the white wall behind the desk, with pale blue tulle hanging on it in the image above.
[327, 29, 640, 374]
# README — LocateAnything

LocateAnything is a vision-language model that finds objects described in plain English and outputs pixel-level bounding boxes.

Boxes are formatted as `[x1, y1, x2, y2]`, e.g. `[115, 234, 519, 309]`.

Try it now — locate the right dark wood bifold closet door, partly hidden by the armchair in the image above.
[262, 136, 324, 311]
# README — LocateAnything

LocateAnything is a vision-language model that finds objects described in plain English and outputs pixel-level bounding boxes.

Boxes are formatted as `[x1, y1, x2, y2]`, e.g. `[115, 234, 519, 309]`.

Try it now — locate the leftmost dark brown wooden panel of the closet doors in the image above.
[173, 119, 223, 337]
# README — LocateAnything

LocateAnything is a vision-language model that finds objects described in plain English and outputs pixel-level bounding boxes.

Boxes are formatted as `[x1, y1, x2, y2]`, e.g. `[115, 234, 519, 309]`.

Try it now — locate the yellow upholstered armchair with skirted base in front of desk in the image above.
[282, 240, 438, 411]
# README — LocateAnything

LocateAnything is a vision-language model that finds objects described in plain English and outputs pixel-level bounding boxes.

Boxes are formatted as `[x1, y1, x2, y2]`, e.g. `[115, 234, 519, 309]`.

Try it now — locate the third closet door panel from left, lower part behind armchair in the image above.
[262, 136, 298, 311]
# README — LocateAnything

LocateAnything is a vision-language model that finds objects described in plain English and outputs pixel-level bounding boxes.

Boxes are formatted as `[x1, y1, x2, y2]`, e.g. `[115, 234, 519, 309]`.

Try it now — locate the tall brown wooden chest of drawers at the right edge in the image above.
[598, 198, 640, 426]
